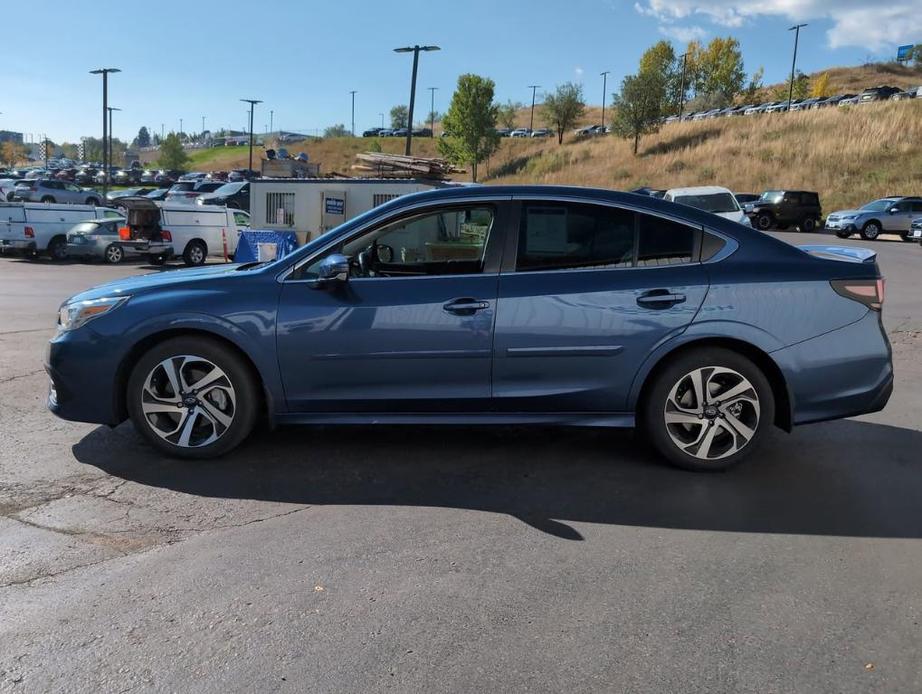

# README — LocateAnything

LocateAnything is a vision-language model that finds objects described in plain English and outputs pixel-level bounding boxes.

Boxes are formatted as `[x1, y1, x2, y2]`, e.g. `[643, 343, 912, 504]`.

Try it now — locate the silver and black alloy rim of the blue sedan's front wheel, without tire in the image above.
[141, 354, 237, 448]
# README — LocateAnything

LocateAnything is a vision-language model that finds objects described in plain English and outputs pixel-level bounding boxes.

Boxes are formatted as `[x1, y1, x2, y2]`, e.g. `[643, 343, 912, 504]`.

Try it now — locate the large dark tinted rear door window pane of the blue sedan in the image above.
[516, 203, 634, 271]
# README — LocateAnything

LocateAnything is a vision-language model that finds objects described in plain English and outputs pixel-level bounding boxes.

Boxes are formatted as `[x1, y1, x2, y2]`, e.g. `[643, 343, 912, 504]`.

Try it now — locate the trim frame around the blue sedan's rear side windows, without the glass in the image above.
[500, 194, 716, 275]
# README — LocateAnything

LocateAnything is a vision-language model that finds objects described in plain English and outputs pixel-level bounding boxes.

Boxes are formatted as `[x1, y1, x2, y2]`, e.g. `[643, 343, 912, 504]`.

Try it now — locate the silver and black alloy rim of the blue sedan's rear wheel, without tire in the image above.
[663, 366, 761, 461]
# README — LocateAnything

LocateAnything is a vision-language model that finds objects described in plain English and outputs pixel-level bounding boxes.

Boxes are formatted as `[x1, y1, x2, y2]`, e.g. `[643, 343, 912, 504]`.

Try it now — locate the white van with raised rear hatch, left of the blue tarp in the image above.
[113, 198, 250, 265]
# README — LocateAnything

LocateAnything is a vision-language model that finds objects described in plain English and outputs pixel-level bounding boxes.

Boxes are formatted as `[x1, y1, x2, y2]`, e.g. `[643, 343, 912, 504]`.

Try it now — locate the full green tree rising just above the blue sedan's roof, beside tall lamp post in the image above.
[438, 74, 499, 181]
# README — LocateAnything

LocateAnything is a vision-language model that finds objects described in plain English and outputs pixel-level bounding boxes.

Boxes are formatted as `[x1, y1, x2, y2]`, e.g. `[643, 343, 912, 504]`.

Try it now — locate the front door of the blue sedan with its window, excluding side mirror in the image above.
[277, 204, 502, 413]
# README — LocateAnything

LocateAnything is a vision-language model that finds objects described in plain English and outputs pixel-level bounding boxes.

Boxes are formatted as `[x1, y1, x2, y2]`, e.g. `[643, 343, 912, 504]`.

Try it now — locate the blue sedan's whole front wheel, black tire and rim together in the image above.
[126, 337, 260, 459]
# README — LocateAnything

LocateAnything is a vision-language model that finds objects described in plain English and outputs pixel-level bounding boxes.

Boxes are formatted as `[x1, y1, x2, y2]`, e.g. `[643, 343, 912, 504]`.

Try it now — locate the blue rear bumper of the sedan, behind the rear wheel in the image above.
[771, 311, 893, 425]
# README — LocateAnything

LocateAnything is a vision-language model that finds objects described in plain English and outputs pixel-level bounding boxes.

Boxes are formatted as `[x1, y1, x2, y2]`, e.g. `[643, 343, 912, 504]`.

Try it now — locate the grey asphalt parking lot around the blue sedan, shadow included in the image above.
[0, 233, 922, 692]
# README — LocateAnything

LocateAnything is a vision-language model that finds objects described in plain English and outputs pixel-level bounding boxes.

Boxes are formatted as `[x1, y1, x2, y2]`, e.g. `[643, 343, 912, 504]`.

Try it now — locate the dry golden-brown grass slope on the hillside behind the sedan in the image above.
[488, 100, 922, 211]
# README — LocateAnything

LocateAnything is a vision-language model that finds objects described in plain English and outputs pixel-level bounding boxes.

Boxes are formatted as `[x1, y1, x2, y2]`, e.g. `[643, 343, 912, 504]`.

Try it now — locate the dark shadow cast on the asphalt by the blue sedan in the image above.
[73, 420, 922, 540]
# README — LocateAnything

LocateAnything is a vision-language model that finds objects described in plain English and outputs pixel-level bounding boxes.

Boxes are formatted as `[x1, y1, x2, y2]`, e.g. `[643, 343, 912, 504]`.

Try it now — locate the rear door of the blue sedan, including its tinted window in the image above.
[493, 199, 708, 412]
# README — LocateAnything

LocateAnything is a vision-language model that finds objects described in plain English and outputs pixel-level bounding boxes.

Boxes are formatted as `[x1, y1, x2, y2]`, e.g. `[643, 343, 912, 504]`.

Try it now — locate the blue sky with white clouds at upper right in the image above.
[0, 0, 922, 142]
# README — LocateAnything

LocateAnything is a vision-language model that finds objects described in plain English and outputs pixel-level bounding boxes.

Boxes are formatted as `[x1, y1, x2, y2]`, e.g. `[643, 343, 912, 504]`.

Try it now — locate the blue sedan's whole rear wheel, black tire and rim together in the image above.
[640, 347, 775, 471]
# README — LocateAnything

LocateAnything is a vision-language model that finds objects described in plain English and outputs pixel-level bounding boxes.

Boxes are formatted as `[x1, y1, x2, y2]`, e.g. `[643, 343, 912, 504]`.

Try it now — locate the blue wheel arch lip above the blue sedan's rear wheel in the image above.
[633, 336, 794, 432]
